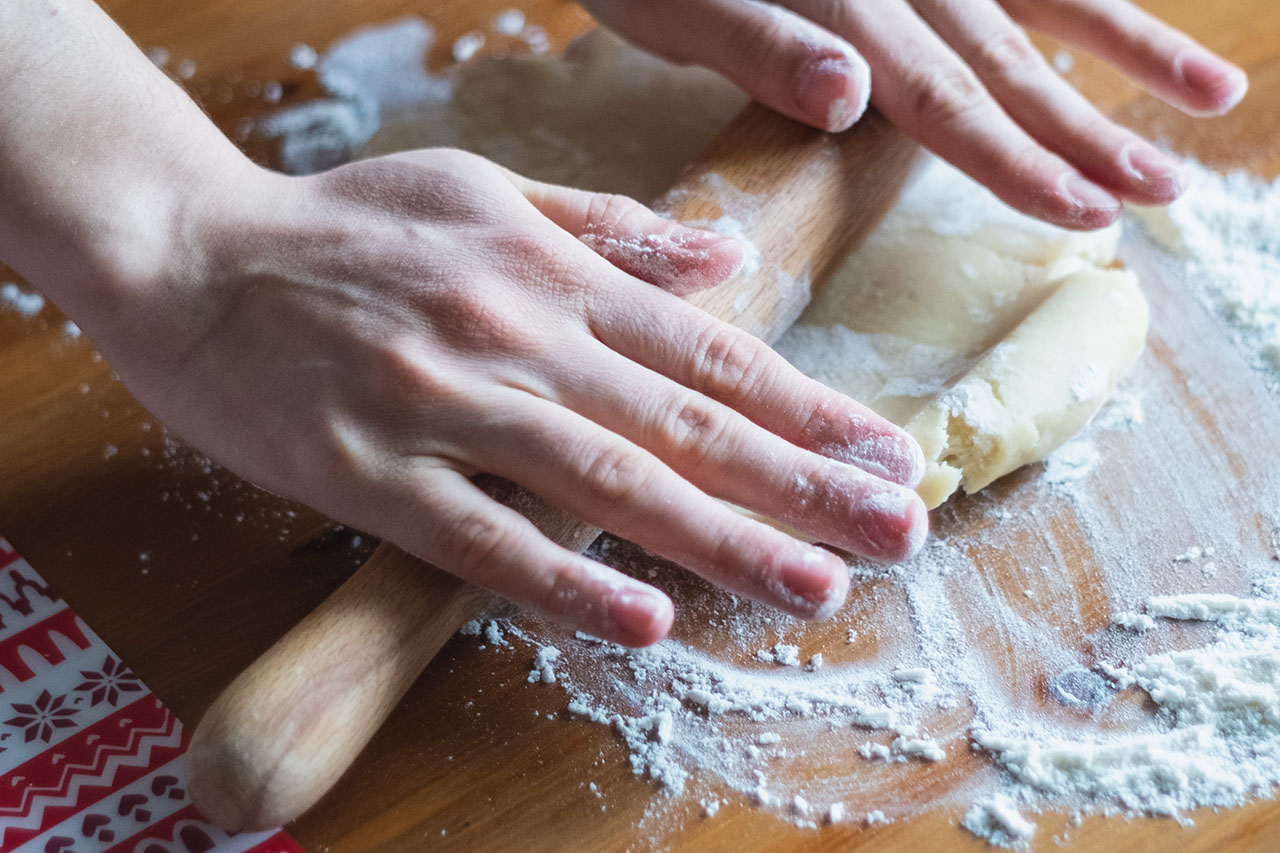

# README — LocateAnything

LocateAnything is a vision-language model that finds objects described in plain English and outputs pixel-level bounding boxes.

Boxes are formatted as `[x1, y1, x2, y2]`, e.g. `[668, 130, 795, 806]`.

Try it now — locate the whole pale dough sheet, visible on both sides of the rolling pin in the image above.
[365, 32, 1147, 507]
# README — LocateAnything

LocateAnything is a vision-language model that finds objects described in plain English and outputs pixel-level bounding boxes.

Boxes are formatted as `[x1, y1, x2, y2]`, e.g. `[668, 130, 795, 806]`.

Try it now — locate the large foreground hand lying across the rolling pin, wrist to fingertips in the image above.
[95, 150, 927, 646]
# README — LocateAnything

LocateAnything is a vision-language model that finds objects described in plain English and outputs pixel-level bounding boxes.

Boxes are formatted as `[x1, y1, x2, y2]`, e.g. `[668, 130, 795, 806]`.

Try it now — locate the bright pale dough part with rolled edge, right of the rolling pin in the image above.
[778, 160, 1147, 508]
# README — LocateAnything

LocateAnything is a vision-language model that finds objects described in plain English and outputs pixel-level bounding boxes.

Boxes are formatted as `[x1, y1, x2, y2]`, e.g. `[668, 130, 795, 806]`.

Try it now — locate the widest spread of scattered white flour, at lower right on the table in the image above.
[478, 308, 1280, 847]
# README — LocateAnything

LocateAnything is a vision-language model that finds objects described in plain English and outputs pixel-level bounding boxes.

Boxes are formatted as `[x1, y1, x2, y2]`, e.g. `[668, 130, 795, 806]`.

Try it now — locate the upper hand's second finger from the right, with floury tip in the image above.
[915, 0, 1183, 205]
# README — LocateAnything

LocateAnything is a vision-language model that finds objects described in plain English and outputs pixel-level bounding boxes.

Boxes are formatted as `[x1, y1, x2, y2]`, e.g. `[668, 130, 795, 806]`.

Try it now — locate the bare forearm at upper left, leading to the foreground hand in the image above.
[0, 0, 247, 326]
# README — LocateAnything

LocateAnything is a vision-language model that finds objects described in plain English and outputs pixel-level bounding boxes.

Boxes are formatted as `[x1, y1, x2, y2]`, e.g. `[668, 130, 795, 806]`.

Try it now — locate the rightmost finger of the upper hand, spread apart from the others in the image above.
[1001, 0, 1249, 115]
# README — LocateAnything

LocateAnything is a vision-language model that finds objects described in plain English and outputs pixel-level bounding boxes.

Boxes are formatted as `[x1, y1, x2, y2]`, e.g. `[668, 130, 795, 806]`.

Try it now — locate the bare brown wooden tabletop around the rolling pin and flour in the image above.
[0, 0, 1280, 850]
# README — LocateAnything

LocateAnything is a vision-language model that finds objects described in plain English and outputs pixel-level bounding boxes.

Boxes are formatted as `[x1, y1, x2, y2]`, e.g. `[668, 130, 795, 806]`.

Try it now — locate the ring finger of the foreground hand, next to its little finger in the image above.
[466, 392, 849, 619]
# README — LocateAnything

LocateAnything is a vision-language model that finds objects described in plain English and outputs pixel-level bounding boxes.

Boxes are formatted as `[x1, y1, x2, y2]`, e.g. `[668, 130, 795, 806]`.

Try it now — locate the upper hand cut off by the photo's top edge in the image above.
[582, 0, 1248, 228]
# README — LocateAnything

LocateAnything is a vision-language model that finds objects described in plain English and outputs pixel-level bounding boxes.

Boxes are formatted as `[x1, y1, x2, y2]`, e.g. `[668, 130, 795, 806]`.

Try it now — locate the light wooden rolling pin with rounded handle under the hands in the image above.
[188, 105, 916, 831]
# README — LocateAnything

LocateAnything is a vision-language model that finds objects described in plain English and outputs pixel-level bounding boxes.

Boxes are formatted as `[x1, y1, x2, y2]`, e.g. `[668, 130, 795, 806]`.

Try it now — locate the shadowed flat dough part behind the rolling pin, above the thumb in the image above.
[364, 29, 746, 201]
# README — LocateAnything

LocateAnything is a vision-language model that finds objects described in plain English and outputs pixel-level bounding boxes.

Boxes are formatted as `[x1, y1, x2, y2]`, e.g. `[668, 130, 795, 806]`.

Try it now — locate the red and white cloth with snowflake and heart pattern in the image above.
[0, 538, 302, 853]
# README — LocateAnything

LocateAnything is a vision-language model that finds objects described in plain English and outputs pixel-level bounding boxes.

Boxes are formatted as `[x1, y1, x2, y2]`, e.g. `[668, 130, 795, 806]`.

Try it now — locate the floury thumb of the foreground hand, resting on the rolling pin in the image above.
[508, 173, 746, 296]
